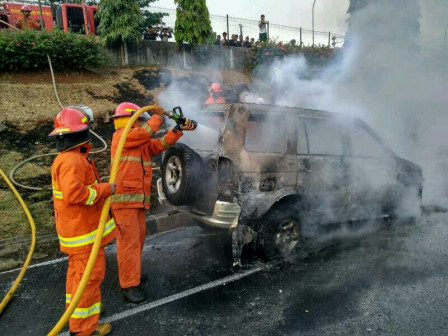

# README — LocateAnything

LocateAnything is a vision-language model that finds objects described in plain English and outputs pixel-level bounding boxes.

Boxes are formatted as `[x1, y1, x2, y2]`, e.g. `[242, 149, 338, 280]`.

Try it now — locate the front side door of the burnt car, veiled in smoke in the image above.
[349, 120, 397, 218]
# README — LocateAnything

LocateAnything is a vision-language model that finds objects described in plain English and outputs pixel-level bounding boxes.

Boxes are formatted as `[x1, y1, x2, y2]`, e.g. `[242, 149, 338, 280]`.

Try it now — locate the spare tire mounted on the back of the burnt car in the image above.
[162, 144, 203, 205]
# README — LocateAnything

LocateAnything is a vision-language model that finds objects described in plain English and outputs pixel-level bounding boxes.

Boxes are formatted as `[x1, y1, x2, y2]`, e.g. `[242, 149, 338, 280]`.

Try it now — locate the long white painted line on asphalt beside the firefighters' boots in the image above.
[59, 266, 264, 336]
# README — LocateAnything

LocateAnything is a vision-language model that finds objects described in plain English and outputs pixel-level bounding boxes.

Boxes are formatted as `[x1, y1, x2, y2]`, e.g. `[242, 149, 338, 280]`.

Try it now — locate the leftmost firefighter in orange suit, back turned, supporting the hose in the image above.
[50, 107, 117, 336]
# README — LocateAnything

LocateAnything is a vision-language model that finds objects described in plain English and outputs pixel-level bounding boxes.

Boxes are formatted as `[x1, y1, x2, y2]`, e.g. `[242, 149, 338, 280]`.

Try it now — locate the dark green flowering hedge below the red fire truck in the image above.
[0, 29, 103, 71]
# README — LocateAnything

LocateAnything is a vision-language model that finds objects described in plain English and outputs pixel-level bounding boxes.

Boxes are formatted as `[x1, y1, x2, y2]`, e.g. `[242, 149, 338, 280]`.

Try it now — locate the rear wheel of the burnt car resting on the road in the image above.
[260, 204, 303, 260]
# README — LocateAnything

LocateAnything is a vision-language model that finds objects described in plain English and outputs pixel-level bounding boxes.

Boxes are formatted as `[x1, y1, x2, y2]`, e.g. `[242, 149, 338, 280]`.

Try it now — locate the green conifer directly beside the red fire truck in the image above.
[97, 0, 144, 45]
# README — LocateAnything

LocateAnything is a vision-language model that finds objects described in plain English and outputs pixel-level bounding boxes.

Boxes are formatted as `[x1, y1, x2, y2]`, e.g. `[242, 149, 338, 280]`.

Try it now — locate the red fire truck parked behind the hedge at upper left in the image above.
[0, 2, 99, 35]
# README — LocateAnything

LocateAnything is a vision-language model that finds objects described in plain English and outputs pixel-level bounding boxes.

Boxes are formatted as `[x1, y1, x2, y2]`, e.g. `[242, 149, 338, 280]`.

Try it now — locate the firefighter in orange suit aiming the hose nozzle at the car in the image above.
[111, 103, 194, 303]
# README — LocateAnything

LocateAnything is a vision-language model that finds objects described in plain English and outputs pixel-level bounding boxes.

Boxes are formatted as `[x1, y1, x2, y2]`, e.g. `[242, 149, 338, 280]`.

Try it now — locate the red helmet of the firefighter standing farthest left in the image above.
[49, 107, 89, 135]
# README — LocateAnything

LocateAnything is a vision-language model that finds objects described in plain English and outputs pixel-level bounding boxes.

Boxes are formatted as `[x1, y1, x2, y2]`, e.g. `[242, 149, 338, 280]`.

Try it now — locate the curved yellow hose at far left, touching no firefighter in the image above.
[0, 169, 36, 315]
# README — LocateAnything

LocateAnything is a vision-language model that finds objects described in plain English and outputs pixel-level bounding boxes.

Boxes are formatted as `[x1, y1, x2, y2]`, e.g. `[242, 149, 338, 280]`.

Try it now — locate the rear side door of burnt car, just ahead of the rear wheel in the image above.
[297, 116, 352, 223]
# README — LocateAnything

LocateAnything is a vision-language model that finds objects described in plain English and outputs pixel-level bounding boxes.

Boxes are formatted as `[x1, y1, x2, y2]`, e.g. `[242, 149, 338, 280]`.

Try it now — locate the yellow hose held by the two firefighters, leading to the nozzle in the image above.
[48, 106, 156, 336]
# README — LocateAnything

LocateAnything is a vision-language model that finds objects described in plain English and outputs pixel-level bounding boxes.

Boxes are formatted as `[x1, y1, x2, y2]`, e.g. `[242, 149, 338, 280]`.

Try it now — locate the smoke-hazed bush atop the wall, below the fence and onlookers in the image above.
[248, 41, 339, 68]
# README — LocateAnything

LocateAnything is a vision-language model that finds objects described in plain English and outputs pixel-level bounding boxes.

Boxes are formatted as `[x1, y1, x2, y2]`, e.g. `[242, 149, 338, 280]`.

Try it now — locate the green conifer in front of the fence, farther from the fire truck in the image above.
[174, 0, 212, 44]
